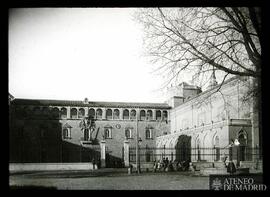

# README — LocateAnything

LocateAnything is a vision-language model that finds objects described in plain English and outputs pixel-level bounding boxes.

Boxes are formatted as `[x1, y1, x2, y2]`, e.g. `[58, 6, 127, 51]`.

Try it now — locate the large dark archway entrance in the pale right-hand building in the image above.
[176, 135, 191, 161]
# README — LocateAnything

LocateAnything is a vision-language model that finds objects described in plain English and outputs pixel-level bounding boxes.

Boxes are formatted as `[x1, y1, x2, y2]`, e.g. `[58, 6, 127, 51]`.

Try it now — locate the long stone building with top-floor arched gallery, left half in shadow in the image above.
[10, 99, 170, 166]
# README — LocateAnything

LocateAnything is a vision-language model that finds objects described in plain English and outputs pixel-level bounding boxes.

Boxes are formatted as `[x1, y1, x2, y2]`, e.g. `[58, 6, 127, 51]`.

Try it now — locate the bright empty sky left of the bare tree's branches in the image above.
[9, 8, 169, 102]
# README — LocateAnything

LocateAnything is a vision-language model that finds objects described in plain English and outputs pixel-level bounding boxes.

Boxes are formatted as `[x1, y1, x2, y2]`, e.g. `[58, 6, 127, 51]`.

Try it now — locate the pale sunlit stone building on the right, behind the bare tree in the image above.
[156, 75, 260, 169]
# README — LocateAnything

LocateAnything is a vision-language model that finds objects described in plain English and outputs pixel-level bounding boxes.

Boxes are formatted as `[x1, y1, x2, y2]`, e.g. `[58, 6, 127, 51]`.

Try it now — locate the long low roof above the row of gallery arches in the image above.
[12, 98, 171, 109]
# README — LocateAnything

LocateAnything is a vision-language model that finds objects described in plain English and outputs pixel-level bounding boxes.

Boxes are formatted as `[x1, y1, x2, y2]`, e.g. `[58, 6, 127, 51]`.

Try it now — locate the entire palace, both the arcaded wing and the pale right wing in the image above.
[9, 73, 260, 169]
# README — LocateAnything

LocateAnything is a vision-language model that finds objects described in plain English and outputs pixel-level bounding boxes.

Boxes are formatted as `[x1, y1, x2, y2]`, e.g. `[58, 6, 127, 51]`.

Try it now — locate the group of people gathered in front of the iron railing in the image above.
[153, 157, 189, 172]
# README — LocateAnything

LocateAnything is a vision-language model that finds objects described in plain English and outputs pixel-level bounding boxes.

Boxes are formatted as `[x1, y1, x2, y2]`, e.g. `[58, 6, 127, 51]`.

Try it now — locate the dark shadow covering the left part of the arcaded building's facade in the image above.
[9, 111, 100, 163]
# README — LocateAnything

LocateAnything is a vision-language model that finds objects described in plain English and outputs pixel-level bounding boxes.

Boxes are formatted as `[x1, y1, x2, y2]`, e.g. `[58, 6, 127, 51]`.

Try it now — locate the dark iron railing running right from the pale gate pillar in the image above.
[129, 146, 262, 162]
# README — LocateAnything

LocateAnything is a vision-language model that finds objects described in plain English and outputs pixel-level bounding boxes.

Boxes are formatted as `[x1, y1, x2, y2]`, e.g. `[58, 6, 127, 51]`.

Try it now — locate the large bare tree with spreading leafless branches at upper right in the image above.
[135, 7, 262, 147]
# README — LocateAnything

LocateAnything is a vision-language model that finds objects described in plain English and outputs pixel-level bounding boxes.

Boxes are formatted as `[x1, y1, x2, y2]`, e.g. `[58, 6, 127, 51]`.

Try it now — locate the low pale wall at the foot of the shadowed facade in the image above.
[9, 162, 97, 172]
